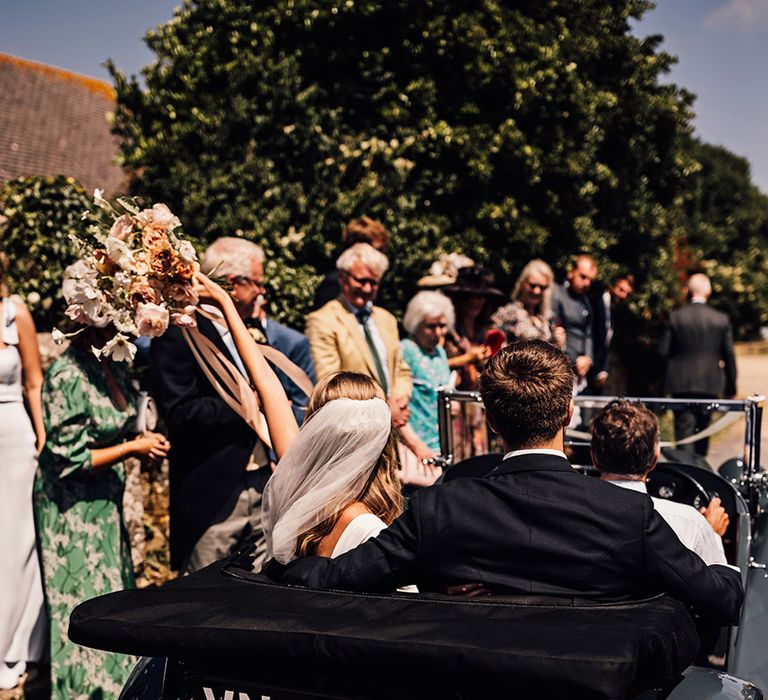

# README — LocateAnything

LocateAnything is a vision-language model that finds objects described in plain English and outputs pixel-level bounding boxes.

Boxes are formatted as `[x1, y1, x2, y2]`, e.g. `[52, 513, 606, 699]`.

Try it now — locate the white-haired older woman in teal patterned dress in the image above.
[401, 292, 454, 459]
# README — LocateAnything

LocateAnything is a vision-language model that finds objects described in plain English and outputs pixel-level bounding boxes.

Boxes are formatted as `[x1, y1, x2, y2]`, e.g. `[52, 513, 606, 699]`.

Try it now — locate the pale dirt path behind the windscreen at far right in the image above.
[708, 343, 768, 467]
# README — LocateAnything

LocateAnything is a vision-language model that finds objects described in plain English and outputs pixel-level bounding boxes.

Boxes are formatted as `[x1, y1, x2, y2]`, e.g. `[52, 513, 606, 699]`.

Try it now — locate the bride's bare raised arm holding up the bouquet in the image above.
[196, 274, 299, 461]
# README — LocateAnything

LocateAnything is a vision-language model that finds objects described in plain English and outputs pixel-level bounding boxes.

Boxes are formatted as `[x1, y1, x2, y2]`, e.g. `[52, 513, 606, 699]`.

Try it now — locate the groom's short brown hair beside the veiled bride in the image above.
[480, 340, 573, 447]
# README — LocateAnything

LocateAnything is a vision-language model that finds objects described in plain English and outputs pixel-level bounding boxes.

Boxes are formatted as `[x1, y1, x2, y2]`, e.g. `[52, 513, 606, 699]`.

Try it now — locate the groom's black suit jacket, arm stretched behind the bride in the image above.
[272, 454, 743, 624]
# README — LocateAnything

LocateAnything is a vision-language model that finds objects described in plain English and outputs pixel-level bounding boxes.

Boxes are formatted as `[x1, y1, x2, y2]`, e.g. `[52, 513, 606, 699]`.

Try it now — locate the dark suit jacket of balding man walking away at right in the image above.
[659, 303, 736, 396]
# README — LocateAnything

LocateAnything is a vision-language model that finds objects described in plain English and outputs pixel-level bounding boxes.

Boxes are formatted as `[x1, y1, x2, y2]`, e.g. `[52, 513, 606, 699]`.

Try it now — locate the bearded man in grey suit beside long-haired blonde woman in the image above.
[552, 254, 597, 393]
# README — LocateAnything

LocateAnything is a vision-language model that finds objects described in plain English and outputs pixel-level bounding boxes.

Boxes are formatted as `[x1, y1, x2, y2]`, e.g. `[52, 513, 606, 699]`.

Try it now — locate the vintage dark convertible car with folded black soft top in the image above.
[70, 392, 768, 700]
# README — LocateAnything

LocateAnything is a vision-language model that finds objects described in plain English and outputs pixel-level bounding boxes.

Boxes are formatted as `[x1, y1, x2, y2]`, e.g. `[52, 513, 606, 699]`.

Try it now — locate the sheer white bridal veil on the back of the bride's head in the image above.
[262, 399, 392, 564]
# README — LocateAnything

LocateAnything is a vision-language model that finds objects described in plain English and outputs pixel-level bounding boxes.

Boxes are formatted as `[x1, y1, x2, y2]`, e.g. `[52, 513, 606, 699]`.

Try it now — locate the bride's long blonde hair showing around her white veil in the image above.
[296, 372, 403, 557]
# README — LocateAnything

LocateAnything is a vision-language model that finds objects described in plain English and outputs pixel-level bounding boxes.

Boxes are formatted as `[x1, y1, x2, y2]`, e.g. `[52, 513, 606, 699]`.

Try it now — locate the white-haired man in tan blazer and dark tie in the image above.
[306, 243, 412, 427]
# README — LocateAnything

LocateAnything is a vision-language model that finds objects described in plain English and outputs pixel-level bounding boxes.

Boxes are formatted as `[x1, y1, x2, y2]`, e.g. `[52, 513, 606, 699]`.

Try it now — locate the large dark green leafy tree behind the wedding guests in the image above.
[112, 0, 694, 326]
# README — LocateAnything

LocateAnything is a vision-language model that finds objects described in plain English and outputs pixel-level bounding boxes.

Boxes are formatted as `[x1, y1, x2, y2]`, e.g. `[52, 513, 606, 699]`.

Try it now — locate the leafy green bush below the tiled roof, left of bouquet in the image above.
[0, 176, 90, 330]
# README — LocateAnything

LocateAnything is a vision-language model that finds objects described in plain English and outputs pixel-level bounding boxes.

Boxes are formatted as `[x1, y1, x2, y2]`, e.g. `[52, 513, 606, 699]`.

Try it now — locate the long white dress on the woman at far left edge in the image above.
[0, 298, 45, 688]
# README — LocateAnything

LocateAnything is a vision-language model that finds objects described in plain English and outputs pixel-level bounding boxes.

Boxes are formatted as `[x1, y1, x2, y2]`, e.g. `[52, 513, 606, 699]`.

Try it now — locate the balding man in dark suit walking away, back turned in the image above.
[659, 273, 736, 457]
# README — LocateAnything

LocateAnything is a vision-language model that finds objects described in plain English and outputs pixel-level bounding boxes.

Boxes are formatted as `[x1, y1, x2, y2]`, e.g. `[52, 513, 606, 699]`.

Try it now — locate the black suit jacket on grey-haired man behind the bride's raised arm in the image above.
[150, 315, 258, 568]
